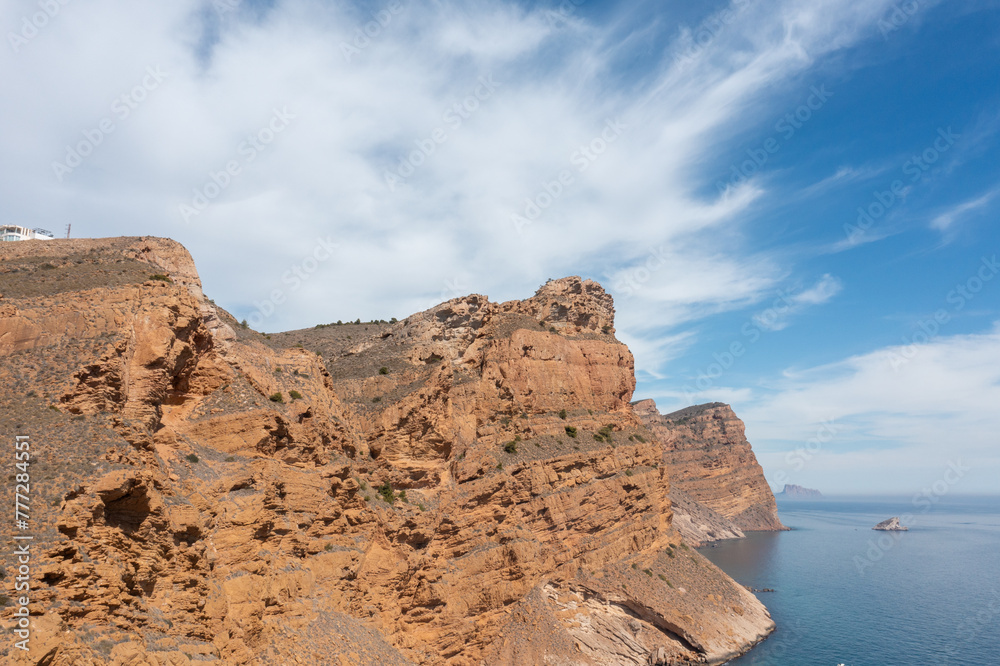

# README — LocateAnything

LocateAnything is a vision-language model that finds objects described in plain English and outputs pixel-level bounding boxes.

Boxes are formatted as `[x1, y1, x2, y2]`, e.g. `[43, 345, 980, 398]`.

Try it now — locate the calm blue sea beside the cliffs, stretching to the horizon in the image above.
[701, 497, 1000, 666]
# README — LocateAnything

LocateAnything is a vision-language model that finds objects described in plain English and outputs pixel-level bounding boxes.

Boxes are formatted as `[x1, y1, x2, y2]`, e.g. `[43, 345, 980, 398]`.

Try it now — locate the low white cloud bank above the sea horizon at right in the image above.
[738, 324, 1000, 492]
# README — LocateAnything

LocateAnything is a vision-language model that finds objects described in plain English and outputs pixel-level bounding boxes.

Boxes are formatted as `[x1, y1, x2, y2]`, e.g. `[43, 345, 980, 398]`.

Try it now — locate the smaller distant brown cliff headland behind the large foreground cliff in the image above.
[635, 400, 785, 542]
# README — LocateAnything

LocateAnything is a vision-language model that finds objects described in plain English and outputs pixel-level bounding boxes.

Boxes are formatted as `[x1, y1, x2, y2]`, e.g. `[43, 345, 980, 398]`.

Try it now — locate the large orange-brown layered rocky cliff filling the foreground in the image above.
[0, 238, 773, 666]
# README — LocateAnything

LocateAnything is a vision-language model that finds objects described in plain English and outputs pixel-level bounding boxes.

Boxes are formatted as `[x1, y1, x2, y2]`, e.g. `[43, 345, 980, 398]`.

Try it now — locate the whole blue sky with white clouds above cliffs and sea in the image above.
[0, 0, 1000, 497]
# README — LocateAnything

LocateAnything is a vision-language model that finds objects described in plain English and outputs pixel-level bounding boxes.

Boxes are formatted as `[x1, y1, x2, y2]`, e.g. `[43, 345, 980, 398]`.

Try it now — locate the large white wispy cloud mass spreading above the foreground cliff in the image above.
[0, 0, 904, 332]
